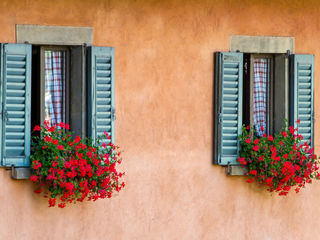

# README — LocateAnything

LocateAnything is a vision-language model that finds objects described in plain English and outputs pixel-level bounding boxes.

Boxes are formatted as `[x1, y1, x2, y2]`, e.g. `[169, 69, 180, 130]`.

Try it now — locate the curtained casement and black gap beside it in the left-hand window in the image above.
[31, 46, 70, 126]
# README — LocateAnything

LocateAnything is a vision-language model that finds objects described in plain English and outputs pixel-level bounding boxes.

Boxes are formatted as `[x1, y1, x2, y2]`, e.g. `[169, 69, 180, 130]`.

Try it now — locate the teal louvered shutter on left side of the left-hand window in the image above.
[0, 44, 32, 167]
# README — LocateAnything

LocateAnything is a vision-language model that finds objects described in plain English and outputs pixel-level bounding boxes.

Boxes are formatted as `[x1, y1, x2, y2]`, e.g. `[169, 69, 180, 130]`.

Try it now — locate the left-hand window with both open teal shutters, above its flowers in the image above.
[0, 44, 115, 167]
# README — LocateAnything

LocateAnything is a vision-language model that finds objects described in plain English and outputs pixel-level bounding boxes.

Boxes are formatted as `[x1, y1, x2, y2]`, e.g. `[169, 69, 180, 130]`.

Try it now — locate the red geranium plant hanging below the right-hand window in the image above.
[238, 120, 320, 196]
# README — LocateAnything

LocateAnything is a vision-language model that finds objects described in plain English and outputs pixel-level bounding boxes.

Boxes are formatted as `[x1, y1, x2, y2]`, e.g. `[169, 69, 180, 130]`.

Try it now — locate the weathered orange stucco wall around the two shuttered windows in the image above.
[0, 0, 320, 240]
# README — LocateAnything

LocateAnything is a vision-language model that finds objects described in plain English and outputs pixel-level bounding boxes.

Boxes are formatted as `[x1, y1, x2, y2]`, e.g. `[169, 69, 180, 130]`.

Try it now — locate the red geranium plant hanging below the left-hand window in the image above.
[30, 122, 125, 208]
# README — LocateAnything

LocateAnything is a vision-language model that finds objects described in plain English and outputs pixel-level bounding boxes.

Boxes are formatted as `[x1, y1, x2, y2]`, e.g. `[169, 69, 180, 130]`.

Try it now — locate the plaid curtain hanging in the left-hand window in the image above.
[44, 51, 65, 125]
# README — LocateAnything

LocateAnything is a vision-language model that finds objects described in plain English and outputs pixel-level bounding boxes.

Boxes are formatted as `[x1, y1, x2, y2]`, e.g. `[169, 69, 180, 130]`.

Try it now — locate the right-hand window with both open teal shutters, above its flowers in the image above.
[214, 52, 314, 165]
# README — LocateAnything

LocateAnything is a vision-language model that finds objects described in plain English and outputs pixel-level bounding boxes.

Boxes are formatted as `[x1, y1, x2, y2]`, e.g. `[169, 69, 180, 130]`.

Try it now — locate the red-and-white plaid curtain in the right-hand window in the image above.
[253, 59, 269, 136]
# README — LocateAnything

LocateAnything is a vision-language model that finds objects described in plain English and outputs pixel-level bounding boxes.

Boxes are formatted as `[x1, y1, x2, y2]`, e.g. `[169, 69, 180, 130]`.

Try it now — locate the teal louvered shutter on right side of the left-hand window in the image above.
[88, 47, 115, 143]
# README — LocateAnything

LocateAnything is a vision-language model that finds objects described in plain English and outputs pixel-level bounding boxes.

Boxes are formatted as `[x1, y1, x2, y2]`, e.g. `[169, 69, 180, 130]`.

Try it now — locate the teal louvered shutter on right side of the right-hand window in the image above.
[290, 54, 314, 146]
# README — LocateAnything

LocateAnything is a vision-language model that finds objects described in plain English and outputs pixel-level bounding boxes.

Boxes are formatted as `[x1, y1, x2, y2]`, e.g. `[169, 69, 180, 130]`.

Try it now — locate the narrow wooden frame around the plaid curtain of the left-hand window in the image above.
[40, 46, 71, 124]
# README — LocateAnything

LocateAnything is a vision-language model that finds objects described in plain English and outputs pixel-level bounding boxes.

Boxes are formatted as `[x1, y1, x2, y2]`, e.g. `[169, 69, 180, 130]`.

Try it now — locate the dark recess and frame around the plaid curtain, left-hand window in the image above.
[31, 45, 87, 137]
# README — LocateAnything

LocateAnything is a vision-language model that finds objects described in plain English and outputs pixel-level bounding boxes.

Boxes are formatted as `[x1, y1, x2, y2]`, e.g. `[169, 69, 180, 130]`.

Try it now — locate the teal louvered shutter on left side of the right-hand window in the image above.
[214, 52, 243, 165]
